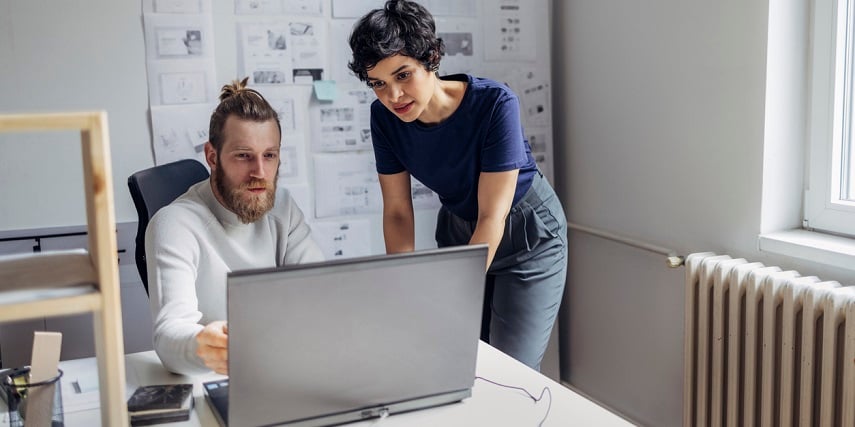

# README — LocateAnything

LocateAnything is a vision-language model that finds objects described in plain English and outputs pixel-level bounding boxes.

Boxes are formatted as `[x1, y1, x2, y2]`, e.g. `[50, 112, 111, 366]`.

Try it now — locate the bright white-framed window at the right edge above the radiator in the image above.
[804, 0, 855, 236]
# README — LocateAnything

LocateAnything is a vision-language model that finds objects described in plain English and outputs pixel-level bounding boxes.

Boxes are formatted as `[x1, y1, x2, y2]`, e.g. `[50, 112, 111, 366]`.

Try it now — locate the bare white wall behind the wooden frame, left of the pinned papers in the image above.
[0, 0, 152, 230]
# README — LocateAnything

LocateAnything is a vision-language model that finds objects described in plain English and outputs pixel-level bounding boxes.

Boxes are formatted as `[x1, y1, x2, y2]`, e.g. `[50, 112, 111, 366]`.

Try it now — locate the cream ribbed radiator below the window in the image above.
[683, 253, 855, 427]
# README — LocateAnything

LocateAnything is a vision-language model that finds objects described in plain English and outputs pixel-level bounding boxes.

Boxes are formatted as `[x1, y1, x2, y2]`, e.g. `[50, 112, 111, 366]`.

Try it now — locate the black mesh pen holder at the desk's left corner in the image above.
[0, 367, 64, 427]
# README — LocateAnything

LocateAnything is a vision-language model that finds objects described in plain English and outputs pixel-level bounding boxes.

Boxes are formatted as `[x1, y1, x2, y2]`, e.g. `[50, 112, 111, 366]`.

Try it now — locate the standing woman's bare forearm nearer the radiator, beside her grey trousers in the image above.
[469, 169, 520, 269]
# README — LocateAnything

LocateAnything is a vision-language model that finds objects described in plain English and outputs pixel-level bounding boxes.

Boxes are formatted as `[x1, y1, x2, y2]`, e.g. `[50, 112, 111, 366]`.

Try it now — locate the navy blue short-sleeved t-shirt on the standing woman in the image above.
[371, 74, 537, 221]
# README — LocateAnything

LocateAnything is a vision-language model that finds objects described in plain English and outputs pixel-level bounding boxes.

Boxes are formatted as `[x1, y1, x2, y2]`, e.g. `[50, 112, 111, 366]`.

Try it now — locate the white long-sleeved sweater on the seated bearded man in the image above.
[145, 180, 323, 374]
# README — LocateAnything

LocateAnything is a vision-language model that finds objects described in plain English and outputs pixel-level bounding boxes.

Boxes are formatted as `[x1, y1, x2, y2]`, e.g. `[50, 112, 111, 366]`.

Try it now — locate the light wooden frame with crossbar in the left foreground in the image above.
[0, 111, 128, 426]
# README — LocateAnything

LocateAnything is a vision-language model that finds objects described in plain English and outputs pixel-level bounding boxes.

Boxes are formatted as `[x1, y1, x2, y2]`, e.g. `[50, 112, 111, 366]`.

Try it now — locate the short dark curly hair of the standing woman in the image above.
[347, 0, 445, 81]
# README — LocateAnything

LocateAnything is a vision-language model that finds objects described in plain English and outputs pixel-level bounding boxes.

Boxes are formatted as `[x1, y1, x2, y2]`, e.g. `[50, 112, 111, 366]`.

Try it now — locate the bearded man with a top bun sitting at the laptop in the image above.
[145, 79, 323, 374]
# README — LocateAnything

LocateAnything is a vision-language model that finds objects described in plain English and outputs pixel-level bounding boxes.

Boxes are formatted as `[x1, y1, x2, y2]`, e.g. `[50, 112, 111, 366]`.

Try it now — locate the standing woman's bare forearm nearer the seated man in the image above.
[379, 171, 416, 254]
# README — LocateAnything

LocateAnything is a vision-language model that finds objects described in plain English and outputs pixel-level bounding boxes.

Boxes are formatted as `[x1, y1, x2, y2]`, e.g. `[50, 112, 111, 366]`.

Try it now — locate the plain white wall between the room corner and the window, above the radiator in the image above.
[553, 0, 855, 426]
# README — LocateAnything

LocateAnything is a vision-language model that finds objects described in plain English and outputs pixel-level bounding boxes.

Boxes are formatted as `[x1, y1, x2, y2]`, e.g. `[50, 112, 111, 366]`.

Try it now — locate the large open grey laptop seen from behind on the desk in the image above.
[204, 245, 487, 427]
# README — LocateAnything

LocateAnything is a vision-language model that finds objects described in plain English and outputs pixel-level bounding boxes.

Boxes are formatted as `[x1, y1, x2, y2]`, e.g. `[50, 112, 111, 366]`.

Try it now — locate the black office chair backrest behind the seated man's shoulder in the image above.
[128, 159, 210, 295]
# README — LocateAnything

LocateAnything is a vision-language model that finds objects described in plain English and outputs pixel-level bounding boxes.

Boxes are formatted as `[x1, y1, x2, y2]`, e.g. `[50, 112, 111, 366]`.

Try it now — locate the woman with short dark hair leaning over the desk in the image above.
[348, 0, 567, 370]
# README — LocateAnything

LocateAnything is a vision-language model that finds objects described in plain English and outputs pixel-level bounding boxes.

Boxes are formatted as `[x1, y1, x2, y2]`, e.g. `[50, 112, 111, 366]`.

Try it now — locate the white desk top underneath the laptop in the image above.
[53, 342, 632, 427]
